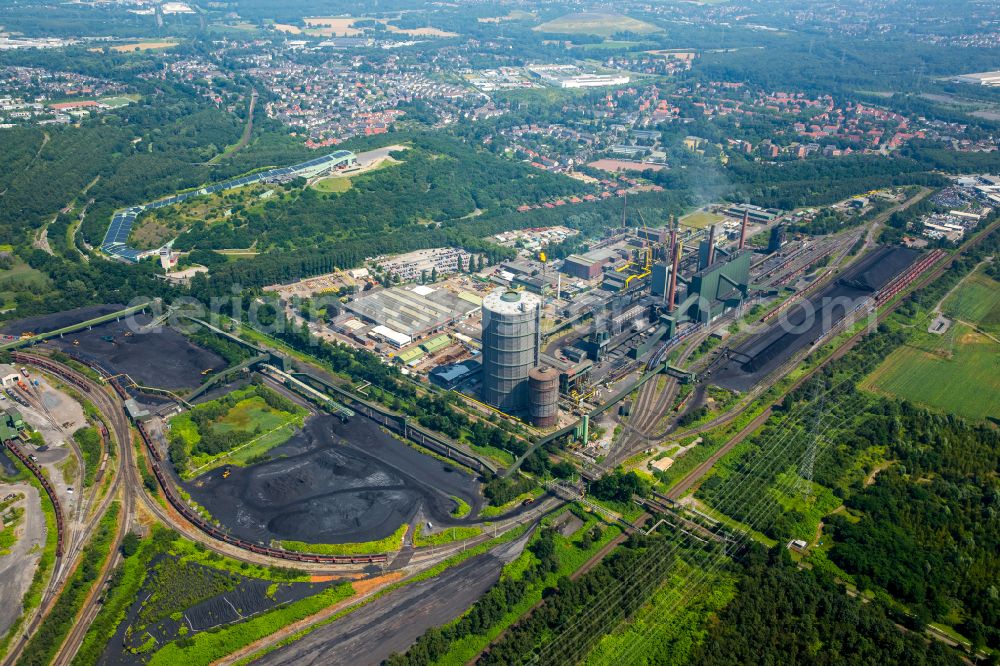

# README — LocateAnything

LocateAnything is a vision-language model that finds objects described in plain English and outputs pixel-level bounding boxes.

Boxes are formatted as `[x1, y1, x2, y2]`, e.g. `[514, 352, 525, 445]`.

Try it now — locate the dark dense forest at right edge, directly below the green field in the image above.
[829, 402, 1000, 648]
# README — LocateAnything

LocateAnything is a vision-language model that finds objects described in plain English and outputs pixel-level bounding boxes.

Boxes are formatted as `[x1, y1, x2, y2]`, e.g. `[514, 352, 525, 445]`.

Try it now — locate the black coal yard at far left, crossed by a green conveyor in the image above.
[5, 305, 226, 390]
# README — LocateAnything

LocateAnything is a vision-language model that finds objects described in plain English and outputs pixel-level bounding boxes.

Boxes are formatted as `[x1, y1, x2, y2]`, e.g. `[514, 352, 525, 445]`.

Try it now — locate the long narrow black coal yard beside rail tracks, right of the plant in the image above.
[710, 247, 918, 391]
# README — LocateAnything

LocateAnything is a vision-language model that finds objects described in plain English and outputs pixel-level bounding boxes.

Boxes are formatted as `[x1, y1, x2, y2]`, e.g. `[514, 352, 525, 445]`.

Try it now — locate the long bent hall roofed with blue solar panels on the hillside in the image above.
[101, 150, 354, 263]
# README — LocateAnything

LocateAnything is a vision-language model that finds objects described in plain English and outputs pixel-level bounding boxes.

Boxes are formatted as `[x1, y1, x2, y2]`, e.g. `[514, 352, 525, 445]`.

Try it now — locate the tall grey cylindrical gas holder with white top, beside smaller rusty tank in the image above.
[483, 289, 542, 414]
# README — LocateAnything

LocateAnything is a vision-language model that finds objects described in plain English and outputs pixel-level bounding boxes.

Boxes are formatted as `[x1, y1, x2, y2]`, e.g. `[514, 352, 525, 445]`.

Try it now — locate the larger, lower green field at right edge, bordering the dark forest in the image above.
[861, 324, 1000, 420]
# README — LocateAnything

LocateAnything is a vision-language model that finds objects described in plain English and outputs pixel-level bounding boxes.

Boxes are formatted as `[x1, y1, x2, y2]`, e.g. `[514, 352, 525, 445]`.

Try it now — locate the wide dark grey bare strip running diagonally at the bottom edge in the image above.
[257, 530, 532, 666]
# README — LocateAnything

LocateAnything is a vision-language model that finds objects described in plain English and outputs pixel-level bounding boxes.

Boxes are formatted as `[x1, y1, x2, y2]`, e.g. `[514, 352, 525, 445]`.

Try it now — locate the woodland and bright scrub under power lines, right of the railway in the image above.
[697, 226, 1000, 648]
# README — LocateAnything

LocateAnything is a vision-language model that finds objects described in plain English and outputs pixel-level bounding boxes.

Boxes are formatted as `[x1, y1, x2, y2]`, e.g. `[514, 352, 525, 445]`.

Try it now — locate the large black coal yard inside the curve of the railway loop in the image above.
[187, 415, 482, 543]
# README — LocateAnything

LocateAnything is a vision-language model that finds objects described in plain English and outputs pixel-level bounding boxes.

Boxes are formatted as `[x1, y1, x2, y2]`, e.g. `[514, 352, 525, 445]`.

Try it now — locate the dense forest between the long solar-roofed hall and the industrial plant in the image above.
[170, 135, 580, 256]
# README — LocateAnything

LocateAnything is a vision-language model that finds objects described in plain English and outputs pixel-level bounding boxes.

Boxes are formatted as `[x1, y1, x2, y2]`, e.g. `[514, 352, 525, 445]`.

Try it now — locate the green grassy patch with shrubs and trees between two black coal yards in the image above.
[169, 386, 307, 478]
